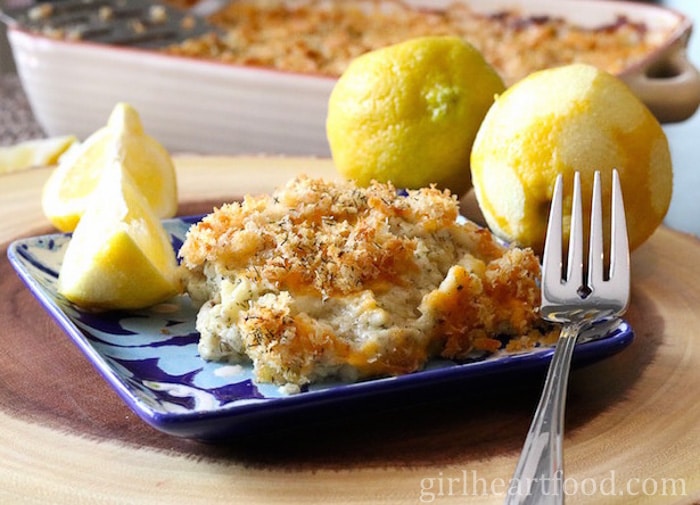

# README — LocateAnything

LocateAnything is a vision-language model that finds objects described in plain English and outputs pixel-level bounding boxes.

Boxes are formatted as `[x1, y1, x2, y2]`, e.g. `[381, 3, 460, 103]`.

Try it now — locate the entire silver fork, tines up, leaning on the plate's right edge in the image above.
[506, 170, 630, 505]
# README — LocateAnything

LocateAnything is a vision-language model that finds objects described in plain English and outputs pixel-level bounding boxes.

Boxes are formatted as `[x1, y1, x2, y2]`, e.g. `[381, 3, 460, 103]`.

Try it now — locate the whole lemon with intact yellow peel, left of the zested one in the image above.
[326, 36, 504, 195]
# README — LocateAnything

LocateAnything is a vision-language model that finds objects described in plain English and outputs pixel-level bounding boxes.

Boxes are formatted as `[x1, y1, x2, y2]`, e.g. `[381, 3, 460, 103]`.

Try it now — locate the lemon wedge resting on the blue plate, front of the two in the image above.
[57, 164, 180, 309]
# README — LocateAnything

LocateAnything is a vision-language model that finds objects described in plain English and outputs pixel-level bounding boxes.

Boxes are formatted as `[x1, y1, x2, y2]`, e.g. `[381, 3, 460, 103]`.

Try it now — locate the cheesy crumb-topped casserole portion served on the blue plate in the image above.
[180, 176, 548, 386]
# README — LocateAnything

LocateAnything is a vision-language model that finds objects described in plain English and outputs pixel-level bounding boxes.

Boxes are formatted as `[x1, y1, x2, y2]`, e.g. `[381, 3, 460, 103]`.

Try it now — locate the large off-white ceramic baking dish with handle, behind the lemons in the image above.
[8, 0, 700, 156]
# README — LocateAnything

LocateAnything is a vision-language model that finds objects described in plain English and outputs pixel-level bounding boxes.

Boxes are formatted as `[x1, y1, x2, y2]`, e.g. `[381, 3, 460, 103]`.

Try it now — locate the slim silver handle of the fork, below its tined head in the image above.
[505, 323, 583, 505]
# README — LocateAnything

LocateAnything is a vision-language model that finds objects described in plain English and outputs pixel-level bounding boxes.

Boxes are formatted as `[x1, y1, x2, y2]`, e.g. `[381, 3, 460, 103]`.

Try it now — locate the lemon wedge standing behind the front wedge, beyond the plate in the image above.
[41, 103, 177, 231]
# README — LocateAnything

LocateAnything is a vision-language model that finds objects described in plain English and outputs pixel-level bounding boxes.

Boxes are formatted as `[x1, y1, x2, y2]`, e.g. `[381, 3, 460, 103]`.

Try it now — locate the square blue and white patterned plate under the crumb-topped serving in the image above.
[8, 216, 634, 439]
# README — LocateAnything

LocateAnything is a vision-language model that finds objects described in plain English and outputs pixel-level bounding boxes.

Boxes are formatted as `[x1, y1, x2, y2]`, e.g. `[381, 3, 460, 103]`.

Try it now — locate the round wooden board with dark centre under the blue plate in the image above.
[0, 156, 700, 505]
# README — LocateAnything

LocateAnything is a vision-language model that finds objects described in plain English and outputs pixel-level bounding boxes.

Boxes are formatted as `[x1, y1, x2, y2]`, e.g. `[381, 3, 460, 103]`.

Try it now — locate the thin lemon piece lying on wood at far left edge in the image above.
[0, 135, 78, 174]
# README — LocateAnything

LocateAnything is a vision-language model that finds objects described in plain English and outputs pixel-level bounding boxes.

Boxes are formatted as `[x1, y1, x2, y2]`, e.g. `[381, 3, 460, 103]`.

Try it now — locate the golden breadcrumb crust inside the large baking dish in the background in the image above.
[165, 0, 669, 85]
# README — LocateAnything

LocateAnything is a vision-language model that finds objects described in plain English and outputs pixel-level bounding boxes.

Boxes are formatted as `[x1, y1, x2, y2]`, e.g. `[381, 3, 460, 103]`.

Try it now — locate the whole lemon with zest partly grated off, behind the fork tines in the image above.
[471, 64, 673, 252]
